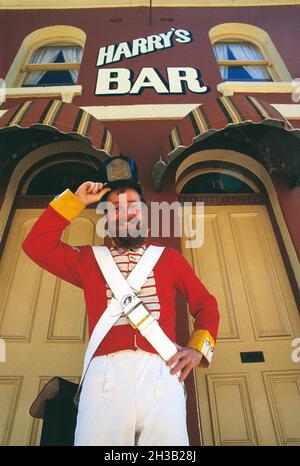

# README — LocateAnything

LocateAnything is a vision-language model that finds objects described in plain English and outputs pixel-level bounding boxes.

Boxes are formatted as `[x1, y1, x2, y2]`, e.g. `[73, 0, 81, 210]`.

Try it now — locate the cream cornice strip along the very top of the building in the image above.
[0, 0, 300, 10]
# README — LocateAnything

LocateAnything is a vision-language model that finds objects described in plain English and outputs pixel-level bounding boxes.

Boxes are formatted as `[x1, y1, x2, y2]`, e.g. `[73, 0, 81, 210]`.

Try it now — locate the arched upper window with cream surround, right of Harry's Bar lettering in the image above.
[209, 23, 292, 82]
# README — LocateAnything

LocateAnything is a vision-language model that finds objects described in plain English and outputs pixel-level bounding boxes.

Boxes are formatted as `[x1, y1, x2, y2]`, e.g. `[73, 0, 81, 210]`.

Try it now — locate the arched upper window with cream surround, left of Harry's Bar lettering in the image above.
[5, 25, 86, 88]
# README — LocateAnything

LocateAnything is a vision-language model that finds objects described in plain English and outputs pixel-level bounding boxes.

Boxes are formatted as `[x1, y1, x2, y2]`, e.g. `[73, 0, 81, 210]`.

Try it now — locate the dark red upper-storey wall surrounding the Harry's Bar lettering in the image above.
[0, 6, 300, 107]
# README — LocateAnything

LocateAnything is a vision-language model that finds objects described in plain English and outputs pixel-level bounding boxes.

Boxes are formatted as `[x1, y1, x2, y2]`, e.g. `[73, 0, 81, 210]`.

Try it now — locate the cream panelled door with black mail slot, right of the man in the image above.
[182, 205, 300, 445]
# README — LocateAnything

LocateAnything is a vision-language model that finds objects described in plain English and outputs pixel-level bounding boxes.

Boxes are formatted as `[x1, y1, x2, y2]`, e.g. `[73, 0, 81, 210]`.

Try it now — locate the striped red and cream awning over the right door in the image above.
[153, 96, 300, 189]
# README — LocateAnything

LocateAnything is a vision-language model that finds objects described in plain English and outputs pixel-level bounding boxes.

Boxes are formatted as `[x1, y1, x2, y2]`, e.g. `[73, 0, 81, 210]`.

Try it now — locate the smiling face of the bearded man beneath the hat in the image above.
[107, 188, 142, 237]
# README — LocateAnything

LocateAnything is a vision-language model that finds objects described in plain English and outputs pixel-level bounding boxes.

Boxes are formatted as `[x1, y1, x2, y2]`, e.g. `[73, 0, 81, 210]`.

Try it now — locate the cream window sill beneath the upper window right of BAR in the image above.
[217, 80, 300, 102]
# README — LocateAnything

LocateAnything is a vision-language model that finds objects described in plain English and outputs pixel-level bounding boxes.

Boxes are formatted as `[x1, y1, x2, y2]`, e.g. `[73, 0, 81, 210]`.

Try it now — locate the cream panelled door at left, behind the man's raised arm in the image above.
[0, 209, 101, 445]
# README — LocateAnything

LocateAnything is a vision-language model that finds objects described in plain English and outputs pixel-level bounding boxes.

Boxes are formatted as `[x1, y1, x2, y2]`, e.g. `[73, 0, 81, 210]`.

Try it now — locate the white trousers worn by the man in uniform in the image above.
[75, 350, 189, 446]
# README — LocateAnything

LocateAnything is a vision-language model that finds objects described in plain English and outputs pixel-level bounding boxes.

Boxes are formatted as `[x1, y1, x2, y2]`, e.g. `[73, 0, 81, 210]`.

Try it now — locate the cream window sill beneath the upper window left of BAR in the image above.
[5, 85, 82, 103]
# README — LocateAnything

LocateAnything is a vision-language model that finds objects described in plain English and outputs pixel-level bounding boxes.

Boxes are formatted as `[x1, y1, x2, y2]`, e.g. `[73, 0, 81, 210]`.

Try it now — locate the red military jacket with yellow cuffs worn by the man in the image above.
[22, 190, 219, 366]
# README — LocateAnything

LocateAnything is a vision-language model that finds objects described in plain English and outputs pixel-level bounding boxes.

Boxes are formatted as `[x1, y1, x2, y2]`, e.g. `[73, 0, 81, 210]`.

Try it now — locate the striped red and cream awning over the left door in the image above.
[0, 99, 120, 156]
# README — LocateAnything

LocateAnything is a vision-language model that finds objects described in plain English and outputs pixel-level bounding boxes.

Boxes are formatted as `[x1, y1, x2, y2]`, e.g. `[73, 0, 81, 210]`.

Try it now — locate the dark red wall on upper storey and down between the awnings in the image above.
[0, 6, 300, 256]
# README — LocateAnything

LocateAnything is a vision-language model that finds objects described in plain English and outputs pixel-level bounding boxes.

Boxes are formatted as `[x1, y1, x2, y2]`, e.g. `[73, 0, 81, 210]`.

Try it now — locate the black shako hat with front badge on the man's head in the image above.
[101, 155, 143, 195]
